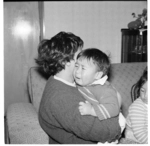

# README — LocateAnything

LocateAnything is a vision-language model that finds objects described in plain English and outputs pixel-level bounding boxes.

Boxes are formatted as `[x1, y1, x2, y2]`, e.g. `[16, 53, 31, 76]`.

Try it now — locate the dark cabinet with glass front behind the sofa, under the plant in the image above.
[121, 29, 147, 63]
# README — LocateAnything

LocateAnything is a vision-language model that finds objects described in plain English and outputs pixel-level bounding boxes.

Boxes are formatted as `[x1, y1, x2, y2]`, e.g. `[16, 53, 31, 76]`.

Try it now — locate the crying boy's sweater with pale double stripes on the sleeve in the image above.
[78, 83, 120, 120]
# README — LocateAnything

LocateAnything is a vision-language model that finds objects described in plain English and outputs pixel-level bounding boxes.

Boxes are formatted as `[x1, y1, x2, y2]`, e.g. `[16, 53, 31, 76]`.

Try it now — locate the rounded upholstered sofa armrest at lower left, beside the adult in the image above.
[6, 103, 49, 144]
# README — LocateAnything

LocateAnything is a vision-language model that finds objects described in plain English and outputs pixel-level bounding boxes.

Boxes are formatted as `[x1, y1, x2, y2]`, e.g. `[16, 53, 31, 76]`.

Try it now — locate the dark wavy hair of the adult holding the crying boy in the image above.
[35, 32, 83, 75]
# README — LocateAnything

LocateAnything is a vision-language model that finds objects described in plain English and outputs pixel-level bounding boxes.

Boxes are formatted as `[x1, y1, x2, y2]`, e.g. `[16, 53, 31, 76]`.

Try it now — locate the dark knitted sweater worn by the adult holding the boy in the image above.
[39, 76, 121, 144]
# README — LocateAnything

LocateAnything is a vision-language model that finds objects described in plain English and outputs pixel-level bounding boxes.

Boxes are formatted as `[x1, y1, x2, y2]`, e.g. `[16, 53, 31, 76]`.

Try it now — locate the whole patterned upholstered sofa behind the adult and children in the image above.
[6, 62, 147, 144]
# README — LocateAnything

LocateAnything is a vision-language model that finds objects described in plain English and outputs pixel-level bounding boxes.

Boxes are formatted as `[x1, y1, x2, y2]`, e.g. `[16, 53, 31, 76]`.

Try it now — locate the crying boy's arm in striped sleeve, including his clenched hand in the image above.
[78, 87, 120, 120]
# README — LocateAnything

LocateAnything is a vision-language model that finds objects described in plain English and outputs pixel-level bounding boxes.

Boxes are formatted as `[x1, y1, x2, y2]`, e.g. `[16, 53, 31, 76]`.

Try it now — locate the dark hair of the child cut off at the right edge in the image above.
[131, 67, 148, 102]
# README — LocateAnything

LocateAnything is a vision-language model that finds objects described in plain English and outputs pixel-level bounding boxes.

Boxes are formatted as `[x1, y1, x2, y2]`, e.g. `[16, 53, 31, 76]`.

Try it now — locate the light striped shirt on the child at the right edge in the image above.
[125, 98, 148, 144]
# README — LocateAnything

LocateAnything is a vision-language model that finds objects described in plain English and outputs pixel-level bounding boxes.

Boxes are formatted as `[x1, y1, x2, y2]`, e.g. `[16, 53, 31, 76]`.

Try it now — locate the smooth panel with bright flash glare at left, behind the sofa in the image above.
[4, 2, 40, 112]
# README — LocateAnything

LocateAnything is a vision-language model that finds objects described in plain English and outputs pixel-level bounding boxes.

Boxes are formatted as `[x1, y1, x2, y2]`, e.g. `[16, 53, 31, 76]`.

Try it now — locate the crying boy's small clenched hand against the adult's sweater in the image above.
[79, 101, 92, 115]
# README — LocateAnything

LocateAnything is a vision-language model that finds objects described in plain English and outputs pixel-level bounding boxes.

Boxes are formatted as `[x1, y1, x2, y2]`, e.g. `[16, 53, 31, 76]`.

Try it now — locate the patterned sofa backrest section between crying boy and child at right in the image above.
[109, 63, 147, 117]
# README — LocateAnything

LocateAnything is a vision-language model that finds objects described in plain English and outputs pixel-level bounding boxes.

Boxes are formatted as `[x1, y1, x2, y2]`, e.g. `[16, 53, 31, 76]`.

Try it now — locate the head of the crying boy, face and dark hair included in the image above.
[74, 48, 110, 86]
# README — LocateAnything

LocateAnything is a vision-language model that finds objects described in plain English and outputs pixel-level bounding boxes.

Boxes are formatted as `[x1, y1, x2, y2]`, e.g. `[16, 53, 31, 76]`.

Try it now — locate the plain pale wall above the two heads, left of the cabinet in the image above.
[44, 1, 147, 63]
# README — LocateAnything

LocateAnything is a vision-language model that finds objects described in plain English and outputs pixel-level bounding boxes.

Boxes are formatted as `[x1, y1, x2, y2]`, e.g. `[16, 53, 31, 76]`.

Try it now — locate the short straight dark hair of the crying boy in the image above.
[77, 48, 110, 76]
